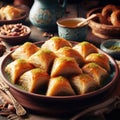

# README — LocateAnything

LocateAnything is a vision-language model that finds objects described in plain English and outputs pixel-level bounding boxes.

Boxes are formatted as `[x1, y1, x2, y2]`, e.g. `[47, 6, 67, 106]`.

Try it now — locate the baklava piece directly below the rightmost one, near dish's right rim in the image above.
[82, 62, 108, 86]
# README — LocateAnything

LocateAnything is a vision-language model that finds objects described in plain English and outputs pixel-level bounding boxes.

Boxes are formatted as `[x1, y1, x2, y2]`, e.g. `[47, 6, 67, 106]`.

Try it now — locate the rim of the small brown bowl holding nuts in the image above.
[0, 24, 31, 39]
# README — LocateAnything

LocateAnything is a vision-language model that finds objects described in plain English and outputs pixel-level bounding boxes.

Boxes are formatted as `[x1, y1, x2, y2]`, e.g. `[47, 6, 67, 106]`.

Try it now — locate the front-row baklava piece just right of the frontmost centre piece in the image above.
[71, 73, 98, 94]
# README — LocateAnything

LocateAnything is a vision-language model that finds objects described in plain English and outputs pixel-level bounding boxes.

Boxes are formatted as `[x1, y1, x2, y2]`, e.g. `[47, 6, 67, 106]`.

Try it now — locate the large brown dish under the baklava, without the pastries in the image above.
[0, 42, 119, 117]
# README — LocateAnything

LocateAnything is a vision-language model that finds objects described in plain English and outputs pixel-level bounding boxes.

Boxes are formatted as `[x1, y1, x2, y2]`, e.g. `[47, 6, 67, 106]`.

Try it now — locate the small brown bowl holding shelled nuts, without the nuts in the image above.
[0, 24, 31, 45]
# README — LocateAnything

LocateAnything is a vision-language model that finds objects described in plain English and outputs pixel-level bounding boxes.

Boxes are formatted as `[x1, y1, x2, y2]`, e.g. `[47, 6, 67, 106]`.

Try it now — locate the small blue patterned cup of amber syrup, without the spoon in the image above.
[57, 18, 87, 41]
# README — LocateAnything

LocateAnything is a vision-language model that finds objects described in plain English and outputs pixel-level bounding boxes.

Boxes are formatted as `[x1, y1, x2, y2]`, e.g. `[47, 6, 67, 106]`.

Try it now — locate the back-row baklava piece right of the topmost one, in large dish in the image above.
[73, 41, 98, 58]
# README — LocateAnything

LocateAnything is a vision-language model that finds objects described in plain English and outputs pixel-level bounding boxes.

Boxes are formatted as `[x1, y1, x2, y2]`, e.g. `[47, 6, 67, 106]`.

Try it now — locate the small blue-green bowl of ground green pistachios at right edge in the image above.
[100, 39, 120, 60]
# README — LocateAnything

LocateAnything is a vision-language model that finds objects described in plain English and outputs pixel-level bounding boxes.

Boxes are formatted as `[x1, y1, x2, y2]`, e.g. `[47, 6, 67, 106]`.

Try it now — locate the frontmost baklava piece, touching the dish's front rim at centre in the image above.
[46, 76, 75, 96]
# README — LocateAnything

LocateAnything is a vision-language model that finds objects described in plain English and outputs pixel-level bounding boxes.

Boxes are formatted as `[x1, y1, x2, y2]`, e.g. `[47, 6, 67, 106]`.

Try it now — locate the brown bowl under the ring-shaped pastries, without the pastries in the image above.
[87, 8, 120, 39]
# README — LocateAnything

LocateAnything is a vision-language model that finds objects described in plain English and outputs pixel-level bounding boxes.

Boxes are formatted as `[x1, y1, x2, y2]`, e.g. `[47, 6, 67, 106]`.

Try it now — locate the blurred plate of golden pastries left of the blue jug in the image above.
[0, 5, 27, 25]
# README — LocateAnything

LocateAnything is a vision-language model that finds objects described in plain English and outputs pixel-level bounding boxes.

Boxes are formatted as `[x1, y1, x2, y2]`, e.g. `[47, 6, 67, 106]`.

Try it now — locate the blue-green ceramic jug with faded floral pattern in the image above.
[29, 0, 67, 31]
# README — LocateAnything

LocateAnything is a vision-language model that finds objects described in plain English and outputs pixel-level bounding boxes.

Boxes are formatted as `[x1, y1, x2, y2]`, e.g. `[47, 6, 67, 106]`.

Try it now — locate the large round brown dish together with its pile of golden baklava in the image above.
[0, 36, 119, 115]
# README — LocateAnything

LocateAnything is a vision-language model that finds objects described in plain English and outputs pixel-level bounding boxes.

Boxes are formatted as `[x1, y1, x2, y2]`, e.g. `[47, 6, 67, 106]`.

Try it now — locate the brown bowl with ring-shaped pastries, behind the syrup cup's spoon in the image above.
[87, 4, 120, 39]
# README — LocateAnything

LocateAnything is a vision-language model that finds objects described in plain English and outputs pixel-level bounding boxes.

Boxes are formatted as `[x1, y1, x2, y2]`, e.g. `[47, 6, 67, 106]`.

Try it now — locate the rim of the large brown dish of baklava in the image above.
[0, 42, 119, 100]
